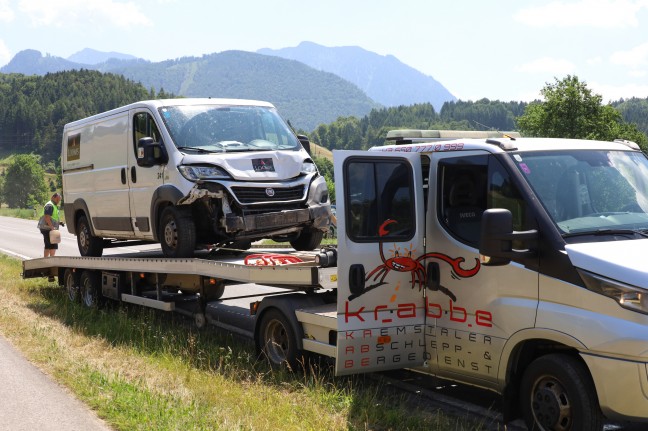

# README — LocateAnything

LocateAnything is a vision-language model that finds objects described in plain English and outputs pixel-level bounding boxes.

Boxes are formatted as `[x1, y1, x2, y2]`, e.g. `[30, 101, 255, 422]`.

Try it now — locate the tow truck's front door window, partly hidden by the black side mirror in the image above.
[438, 155, 526, 247]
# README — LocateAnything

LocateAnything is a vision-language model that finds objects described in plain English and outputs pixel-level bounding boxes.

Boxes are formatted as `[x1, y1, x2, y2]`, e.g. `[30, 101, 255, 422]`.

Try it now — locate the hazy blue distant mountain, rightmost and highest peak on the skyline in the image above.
[257, 42, 457, 112]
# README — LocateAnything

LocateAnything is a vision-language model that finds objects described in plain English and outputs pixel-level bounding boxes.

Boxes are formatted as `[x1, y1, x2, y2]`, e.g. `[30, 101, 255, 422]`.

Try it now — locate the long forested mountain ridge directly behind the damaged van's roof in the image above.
[0, 50, 381, 131]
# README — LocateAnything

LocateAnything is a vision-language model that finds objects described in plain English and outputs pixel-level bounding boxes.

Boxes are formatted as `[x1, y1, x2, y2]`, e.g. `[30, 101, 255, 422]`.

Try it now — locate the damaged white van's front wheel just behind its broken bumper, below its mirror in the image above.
[159, 207, 196, 257]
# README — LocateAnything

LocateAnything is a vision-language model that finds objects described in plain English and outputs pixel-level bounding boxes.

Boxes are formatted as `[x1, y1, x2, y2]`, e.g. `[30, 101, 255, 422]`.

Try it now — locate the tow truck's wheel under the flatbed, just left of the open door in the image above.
[257, 309, 300, 370]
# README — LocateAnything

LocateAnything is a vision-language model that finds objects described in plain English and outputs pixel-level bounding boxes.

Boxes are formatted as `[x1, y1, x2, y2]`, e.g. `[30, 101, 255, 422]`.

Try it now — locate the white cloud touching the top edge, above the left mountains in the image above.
[17, 0, 151, 27]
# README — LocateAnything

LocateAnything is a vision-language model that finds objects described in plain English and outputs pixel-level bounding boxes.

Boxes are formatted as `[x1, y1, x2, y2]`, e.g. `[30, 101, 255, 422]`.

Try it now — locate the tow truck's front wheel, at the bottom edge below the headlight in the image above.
[520, 354, 604, 431]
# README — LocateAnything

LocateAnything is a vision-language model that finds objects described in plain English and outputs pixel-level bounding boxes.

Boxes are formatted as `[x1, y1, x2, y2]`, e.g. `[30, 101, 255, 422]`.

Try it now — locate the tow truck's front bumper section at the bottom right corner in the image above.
[581, 354, 648, 422]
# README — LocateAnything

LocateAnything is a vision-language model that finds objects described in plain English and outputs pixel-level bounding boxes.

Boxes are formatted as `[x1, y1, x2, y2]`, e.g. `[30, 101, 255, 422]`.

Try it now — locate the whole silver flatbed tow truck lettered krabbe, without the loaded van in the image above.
[23, 130, 648, 431]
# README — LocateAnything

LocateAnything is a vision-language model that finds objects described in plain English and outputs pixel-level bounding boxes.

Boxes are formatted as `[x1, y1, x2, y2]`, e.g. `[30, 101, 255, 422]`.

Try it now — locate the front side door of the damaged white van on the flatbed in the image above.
[126, 109, 166, 239]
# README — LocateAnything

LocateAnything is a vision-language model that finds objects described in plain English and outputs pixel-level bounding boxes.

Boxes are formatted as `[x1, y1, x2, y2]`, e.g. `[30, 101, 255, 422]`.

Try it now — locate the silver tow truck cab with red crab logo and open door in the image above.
[334, 131, 648, 429]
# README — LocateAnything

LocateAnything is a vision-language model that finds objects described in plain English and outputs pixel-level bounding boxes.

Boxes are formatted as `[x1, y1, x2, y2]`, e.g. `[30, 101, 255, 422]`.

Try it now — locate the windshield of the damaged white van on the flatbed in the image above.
[159, 105, 301, 153]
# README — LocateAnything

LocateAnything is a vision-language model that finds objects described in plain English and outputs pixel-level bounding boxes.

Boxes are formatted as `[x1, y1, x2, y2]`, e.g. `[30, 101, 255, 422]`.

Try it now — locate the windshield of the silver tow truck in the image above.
[512, 150, 648, 237]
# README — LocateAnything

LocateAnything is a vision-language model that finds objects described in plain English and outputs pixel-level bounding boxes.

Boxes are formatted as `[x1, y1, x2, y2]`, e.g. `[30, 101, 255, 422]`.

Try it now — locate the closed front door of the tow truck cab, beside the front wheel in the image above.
[423, 151, 538, 389]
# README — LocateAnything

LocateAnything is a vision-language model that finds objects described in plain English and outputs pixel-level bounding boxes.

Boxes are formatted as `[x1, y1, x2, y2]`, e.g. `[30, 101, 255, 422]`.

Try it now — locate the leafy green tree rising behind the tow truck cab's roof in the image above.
[518, 75, 648, 148]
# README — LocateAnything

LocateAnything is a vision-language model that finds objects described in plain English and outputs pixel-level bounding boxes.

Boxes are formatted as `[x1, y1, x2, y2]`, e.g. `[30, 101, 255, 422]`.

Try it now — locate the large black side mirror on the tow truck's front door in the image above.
[479, 208, 538, 266]
